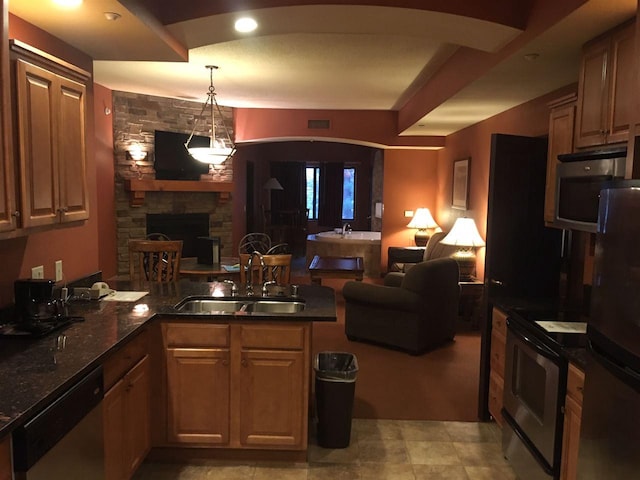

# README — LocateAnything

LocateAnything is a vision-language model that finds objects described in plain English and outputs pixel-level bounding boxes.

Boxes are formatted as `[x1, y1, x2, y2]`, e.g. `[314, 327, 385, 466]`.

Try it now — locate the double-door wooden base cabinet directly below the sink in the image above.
[162, 322, 311, 450]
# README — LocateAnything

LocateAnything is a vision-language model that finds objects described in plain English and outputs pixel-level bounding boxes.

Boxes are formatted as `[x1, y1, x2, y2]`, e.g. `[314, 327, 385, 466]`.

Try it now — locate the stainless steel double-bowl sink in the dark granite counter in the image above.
[175, 297, 305, 315]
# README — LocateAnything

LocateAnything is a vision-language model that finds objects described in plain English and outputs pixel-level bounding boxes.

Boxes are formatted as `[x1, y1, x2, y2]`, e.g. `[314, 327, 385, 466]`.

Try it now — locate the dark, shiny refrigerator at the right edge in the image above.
[578, 181, 640, 480]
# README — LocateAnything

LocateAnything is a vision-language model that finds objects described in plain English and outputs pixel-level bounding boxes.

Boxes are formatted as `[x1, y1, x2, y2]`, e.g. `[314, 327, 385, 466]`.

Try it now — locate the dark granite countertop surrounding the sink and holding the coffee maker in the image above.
[0, 280, 336, 438]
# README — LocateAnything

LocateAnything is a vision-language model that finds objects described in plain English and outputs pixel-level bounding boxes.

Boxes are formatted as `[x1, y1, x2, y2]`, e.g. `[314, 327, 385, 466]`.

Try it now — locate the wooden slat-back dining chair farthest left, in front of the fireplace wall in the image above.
[129, 240, 182, 283]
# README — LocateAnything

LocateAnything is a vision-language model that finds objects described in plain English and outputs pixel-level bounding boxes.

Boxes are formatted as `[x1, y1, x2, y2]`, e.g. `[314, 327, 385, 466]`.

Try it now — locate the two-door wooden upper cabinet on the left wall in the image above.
[12, 41, 89, 228]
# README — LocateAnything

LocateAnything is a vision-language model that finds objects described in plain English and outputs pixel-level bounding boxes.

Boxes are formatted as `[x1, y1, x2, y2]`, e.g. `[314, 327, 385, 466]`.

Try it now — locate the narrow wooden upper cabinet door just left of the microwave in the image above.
[544, 97, 576, 224]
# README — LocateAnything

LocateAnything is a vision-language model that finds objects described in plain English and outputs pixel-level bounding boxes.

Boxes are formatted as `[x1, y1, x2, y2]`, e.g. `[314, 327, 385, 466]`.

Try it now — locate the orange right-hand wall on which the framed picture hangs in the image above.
[434, 85, 577, 278]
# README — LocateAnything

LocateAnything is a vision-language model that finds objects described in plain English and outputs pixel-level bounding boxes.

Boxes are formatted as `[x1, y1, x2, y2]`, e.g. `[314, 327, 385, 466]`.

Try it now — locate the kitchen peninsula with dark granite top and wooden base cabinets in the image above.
[0, 280, 336, 479]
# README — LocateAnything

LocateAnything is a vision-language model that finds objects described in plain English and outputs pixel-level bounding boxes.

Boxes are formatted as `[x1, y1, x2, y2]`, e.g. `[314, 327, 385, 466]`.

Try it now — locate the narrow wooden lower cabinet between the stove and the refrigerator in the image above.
[560, 363, 584, 480]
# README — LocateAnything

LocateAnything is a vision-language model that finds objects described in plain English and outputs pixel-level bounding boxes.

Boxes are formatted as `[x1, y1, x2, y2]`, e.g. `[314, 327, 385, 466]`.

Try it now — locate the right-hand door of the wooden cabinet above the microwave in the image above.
[607, 24, 635, 143]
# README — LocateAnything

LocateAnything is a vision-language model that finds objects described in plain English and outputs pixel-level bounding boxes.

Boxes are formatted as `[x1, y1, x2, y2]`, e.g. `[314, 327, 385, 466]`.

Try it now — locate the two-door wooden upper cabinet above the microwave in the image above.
[575, 23, 635, 148]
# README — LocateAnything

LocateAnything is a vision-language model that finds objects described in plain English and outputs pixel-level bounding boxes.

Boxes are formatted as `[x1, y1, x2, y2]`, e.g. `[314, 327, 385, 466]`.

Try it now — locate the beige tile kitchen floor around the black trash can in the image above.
[134, 419, 516, 480]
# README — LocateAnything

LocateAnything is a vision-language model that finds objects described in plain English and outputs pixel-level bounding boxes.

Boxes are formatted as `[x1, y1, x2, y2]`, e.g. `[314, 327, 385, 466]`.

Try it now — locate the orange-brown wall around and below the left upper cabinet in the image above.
[0, 17, 100, 308]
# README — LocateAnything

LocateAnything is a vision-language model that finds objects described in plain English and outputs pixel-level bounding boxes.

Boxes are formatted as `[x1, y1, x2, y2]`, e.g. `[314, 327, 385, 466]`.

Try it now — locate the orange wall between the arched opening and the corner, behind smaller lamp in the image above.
[380, 150, 438, 271]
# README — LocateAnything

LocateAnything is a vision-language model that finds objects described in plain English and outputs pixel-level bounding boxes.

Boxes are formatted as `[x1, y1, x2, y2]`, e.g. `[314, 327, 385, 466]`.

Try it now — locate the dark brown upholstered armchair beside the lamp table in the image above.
[342, 258, 460, 355]
